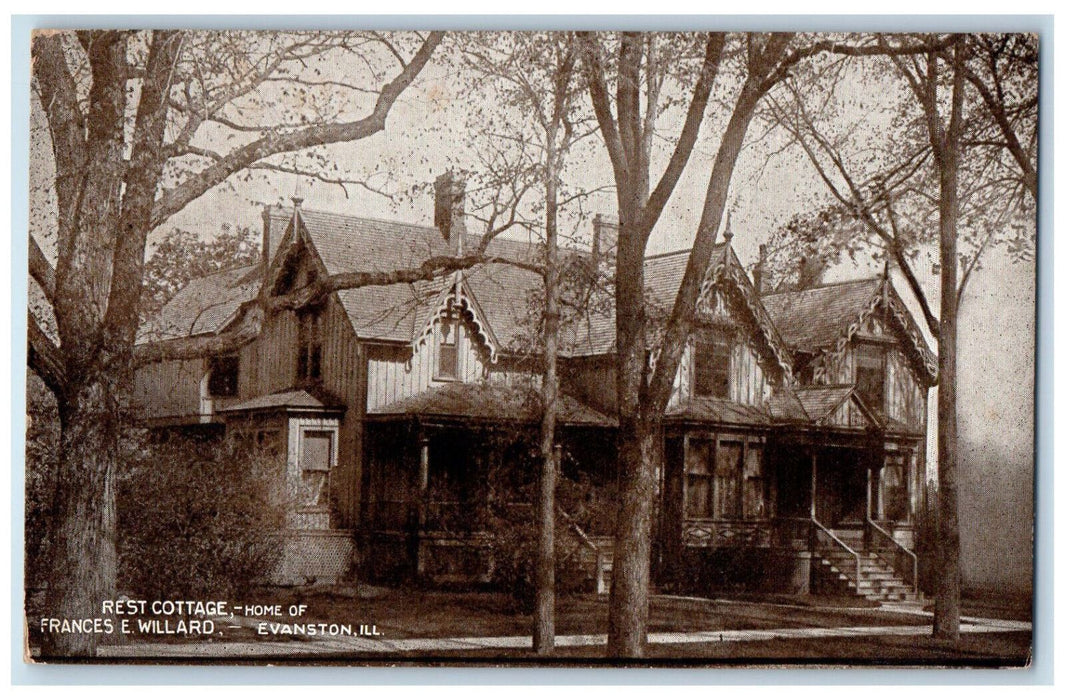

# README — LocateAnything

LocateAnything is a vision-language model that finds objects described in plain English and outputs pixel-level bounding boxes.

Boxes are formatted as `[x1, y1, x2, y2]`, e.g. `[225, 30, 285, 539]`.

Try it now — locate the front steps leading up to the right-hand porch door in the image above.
[813, 531, 923, 603]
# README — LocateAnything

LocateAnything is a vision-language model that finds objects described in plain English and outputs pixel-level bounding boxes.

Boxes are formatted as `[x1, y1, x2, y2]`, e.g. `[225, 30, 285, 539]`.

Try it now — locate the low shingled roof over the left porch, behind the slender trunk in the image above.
[366, 382, 617, 427]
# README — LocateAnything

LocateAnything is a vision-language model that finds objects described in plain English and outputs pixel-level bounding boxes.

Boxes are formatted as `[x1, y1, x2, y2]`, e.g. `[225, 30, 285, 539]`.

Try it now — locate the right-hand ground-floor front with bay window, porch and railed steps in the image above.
[659, 419, 921, 600]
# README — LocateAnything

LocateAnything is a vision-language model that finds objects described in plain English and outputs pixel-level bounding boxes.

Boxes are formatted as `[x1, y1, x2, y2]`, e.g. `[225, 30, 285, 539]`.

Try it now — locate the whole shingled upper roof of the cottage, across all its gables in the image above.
[148, 202, 935, 387]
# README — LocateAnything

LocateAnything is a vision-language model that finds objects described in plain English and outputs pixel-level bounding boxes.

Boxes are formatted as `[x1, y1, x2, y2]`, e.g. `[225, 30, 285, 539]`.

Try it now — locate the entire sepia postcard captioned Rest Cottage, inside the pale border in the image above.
[23, 27, 1044, 668]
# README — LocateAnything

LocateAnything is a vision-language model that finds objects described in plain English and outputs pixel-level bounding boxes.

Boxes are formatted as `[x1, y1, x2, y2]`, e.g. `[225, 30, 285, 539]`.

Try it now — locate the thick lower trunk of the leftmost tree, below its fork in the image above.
[39, 380, 119, 657]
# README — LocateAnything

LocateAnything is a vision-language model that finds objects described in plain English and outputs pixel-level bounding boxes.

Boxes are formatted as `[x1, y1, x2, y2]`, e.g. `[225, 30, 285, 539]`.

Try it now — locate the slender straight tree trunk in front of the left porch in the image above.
[533, 139, 559, 654]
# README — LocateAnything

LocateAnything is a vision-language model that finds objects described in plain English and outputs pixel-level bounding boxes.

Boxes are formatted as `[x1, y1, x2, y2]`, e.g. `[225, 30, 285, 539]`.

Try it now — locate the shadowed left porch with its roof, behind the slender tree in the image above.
[361, 385, 615, 584]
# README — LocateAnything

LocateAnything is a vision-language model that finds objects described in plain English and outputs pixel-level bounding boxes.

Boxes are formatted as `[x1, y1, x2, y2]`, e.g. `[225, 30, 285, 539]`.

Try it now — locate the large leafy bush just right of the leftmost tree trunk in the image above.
[118, 437, 285, 599]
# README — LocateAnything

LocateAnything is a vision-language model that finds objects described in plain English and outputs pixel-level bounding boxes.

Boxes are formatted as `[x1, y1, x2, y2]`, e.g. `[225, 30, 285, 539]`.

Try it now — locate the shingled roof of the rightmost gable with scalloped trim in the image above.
[761, 276, 938, 384]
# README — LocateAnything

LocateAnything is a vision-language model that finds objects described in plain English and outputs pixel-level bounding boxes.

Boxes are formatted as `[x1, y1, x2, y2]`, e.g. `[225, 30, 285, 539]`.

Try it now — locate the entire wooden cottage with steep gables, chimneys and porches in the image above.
[135, 179, 935, 599]
